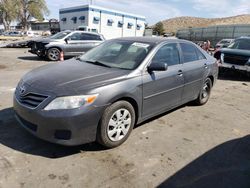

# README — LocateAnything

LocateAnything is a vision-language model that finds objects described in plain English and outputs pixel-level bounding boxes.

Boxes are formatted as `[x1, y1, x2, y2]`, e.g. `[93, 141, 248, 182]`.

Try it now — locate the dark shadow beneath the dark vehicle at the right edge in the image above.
[218, 68, 250, 82]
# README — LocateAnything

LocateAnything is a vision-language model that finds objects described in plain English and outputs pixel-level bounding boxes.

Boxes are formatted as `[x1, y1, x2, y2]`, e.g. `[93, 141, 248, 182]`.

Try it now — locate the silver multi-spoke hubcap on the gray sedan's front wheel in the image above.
[107, 109, 131, 142]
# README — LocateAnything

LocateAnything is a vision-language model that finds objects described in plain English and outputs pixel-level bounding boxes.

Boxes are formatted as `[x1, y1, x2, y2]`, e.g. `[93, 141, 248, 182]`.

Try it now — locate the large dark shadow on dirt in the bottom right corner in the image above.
[158, 136, 250, 188]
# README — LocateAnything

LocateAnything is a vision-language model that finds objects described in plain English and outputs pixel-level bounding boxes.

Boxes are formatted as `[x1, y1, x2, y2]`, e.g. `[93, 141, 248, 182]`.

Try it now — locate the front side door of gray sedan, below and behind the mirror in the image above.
[142, 43, 184, 118]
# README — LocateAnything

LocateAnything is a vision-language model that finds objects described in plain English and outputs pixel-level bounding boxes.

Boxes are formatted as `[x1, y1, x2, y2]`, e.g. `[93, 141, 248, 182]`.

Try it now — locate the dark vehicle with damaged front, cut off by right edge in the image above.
[214, 37, 250, 73]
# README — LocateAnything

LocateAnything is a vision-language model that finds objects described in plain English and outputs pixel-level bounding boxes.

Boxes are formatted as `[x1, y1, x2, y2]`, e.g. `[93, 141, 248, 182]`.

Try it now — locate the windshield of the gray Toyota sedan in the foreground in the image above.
[79, 40, 153, 70]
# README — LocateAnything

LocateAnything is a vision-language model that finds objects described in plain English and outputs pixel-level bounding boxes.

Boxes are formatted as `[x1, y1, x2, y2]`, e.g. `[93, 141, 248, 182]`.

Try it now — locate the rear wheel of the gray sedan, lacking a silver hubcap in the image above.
[195, 78, 212, 106]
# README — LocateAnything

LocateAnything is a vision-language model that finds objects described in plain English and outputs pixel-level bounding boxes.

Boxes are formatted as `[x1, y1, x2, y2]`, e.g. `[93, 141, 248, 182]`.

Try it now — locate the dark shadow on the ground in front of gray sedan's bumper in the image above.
[0, 108, 104, 158]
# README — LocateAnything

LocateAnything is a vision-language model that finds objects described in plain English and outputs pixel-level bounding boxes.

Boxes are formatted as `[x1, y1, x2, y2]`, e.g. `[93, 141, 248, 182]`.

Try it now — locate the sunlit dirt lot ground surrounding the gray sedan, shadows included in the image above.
[0, 48, 250, 188]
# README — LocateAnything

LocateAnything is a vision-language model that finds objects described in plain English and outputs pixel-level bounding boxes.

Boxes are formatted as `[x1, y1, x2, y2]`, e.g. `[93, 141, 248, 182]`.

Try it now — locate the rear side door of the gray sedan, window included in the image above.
[180, 43, 208, 103]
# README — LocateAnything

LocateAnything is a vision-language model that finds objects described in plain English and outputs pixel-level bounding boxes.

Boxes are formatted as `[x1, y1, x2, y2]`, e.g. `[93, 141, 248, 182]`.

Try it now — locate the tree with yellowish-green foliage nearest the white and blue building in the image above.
[17, 0, 49, 30]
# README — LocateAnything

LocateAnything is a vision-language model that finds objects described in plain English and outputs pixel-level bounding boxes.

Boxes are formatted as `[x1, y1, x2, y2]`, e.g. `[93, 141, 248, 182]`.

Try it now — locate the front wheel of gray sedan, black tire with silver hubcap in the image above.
[97, 101, 135, 148]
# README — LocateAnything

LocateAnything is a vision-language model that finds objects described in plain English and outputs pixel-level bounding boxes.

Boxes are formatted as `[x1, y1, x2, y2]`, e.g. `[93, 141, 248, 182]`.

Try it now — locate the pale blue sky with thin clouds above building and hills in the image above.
[46, 0, 250, 25]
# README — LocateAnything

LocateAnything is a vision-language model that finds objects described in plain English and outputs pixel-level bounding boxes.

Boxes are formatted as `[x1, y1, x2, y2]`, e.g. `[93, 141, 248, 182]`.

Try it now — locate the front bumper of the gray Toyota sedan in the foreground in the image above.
[14, 97, 105, 146]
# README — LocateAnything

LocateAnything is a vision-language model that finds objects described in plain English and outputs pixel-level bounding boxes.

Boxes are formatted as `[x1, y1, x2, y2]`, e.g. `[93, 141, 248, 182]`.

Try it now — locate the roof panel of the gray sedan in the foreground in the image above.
[114, 37, 189, 44]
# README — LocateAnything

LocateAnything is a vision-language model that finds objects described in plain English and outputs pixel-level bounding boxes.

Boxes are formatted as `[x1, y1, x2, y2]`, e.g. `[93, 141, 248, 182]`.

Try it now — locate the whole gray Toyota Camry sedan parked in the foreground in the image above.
[14, 37, 218, 148]
